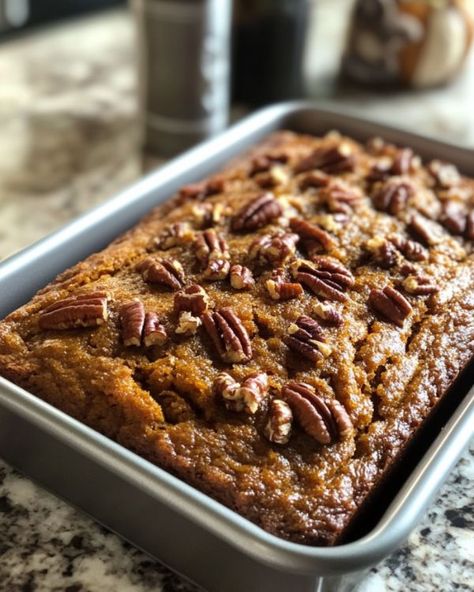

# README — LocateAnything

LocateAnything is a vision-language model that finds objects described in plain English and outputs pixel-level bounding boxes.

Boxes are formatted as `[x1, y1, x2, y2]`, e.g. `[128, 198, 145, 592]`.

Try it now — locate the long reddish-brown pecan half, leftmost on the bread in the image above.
[38, 292, 108, 330]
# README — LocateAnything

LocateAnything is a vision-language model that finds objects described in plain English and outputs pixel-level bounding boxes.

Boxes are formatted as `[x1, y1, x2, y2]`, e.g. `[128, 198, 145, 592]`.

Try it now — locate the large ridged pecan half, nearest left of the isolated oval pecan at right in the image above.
[291, 257, 354, 302]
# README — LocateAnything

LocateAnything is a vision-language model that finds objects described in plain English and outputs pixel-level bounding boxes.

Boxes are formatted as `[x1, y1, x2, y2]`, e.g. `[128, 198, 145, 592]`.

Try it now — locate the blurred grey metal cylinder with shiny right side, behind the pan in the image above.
[132, 0, 232, 157]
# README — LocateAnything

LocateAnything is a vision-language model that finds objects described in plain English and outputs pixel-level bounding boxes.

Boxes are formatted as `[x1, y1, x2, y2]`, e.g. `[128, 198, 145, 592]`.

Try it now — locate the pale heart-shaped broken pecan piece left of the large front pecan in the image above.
[214, 372, 268, 415]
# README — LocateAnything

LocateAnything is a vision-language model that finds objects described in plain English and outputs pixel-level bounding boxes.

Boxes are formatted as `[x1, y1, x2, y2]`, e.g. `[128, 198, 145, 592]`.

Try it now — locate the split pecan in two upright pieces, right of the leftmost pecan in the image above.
[120, 300, 168, 347]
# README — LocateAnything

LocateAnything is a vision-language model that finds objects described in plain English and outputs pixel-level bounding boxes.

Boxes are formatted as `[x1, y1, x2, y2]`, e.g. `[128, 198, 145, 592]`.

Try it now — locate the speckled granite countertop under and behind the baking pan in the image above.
[0, 5, 474, 592]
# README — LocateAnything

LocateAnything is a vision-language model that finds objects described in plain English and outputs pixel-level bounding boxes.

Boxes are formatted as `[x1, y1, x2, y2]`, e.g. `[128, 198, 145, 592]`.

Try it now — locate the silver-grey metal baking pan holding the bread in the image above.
[0, 103, 474, 592]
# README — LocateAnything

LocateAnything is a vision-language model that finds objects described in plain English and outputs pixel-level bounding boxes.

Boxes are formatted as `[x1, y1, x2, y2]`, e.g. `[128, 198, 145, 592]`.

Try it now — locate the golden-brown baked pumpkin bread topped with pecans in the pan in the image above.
[0, 132, 474, 545]
